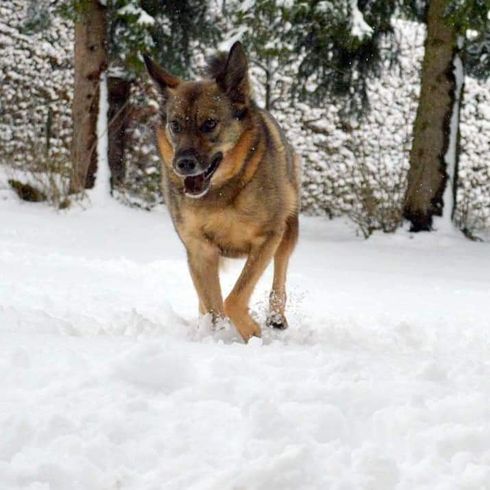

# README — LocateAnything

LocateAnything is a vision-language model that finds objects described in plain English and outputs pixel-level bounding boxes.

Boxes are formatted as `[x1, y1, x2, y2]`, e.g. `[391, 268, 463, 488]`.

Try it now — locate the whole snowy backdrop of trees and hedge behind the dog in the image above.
[0, 0, 490, 239]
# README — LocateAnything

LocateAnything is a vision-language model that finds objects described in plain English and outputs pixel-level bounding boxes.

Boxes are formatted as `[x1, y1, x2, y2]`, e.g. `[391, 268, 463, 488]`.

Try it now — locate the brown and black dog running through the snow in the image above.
[145, 42, 300, 341]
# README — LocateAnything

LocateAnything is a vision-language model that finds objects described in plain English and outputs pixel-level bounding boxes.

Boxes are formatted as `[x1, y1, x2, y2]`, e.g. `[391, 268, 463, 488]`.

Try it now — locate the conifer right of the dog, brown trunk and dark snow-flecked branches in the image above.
[290, 0, 490, 231]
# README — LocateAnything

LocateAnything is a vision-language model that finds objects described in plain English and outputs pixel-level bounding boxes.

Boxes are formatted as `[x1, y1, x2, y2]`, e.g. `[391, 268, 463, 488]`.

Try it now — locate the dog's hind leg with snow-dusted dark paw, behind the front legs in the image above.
[267, 215, 298, 330]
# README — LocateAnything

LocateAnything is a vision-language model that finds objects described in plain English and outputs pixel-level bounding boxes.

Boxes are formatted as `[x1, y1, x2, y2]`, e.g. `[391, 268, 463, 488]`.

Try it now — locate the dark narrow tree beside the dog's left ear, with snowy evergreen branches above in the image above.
[107, 0, 218, 193]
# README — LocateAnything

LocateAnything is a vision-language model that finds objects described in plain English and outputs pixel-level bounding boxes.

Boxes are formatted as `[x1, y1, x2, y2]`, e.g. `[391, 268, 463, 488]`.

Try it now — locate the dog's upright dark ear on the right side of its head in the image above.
[216, 41, 250, 104]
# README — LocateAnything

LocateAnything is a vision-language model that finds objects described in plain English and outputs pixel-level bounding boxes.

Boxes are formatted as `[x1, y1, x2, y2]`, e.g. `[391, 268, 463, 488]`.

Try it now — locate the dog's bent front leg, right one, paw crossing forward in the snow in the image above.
[225, 233, 282, 341]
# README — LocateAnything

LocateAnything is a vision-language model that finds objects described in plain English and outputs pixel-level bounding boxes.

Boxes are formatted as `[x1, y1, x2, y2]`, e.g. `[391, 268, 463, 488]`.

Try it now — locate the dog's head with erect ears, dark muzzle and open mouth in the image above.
[144, 42, 250, 198]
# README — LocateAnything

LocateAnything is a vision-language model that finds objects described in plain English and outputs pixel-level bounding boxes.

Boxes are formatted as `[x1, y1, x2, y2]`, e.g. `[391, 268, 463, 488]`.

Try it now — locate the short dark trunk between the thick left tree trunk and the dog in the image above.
[108, 77, 131, 189]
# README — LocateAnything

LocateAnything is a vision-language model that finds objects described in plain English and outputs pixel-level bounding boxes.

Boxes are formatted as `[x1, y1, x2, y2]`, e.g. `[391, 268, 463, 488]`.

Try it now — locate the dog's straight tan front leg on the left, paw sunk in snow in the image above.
[186, 240, 224, 323]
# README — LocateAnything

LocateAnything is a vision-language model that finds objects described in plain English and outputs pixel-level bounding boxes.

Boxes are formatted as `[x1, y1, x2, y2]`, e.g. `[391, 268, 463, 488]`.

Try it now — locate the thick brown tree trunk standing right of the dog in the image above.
[404, 0, 458, 231]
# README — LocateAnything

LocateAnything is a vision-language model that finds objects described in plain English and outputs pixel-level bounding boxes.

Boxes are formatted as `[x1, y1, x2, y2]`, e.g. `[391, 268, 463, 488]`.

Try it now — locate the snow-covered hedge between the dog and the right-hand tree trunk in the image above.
[274, 22, 424, 236]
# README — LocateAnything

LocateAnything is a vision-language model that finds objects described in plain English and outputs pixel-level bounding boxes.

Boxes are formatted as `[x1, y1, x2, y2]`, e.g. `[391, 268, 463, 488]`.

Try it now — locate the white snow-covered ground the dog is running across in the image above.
[0, 191, 490, 490]
